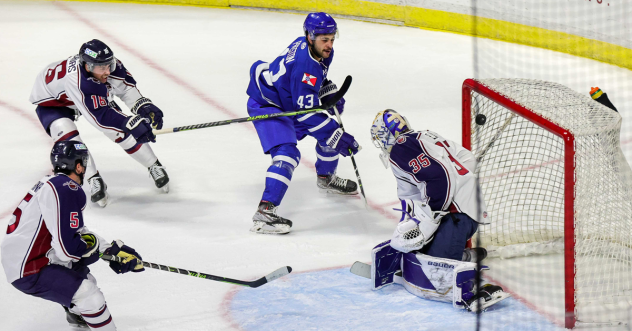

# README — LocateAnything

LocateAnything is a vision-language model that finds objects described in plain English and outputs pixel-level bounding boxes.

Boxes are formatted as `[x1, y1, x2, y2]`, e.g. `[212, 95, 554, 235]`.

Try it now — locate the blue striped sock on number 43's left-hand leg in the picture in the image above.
[261, 144, 301, 206]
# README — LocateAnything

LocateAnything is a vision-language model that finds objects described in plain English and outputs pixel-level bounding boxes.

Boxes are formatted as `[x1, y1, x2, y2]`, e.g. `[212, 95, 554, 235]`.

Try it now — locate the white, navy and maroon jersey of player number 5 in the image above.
[0, 174, 109, 283]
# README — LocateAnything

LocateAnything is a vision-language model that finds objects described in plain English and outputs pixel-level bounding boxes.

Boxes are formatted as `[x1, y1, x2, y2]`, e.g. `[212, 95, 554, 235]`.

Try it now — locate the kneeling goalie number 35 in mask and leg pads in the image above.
[371, 109, 509, 311]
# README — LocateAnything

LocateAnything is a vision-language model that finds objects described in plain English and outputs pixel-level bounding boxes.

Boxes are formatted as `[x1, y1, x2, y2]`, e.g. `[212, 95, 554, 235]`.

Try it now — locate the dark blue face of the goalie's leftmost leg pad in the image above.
[371, 240, 402, 290]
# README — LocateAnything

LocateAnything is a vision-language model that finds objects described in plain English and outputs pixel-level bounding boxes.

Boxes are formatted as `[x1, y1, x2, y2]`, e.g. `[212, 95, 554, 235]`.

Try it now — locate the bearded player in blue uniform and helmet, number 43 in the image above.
[247, 13, 360, 234]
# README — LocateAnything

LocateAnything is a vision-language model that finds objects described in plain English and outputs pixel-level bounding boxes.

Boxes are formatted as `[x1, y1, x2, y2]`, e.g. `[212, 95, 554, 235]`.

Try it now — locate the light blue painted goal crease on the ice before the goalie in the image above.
[230, 268, 561, 331]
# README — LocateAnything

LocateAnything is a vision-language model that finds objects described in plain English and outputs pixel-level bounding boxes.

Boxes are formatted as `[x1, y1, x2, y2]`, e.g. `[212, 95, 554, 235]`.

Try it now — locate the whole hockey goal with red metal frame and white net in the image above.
[462, 79, 632, 328]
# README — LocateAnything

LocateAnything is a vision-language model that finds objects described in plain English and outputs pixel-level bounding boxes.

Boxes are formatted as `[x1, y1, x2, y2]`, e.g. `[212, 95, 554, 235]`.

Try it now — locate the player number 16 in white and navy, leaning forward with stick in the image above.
[29, 39, 169, 207]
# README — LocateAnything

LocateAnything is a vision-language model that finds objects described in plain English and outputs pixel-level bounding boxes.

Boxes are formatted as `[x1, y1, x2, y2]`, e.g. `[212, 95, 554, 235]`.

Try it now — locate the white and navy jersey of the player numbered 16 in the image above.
[29, 55, 142, 134]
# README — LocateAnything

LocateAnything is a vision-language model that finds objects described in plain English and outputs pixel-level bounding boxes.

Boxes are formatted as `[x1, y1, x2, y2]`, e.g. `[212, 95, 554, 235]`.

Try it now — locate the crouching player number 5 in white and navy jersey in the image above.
[1, 140, 144, 331]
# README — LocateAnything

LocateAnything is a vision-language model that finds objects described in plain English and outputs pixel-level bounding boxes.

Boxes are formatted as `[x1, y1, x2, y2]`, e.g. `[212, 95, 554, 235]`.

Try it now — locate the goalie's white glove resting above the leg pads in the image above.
[391, 200, 448, 253]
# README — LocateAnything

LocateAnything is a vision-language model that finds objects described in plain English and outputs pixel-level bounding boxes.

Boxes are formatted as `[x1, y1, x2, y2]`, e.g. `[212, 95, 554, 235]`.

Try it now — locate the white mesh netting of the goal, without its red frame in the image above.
[470, 79, 632, 323]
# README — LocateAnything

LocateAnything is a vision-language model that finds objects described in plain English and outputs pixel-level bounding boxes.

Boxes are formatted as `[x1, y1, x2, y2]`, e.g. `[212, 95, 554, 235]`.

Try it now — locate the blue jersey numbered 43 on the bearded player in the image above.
[246, 37, 334, 111]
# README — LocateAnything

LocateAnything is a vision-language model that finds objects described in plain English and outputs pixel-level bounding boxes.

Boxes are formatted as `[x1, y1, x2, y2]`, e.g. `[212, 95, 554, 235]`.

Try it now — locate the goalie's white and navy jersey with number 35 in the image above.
[389, 131, 487, 223]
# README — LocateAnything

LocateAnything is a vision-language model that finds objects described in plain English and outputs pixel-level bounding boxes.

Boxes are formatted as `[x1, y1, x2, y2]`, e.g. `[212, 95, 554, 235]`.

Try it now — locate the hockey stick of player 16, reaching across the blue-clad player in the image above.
[153, 76, 351, 135]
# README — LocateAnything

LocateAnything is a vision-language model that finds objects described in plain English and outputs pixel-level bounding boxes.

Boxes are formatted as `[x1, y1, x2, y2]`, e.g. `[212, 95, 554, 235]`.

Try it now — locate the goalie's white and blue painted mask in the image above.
[371, 109, 412, 169]
